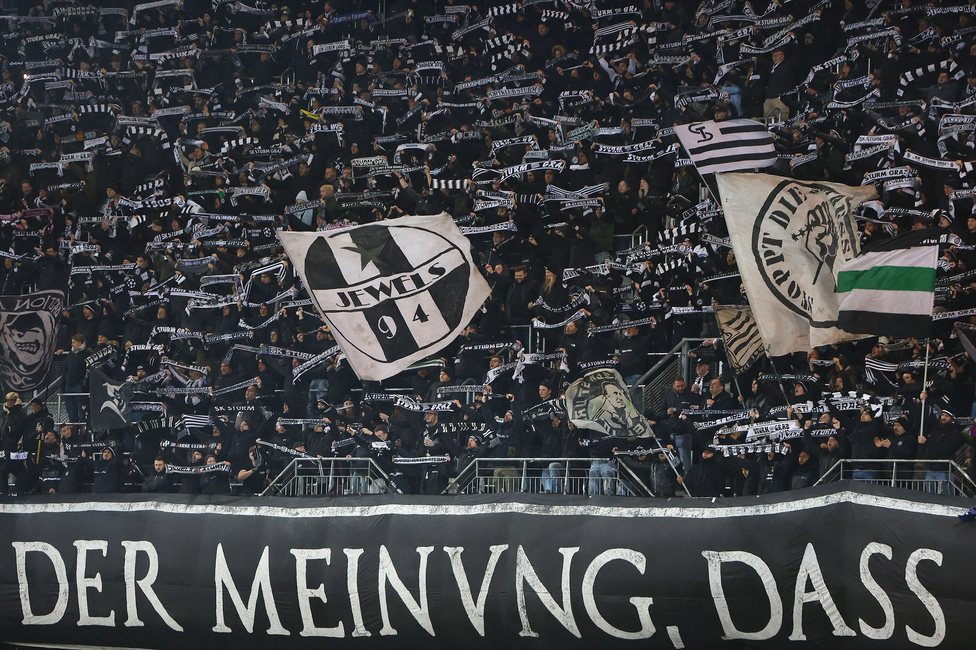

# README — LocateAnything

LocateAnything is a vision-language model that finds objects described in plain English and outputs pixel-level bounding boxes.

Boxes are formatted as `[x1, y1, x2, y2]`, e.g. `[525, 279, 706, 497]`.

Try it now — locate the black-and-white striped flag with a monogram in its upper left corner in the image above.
[674, 120, 776, 176]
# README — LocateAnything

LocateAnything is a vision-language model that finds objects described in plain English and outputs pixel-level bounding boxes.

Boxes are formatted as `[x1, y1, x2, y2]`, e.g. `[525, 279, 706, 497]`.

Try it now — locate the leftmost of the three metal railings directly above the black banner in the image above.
[261, 458, 402, 497]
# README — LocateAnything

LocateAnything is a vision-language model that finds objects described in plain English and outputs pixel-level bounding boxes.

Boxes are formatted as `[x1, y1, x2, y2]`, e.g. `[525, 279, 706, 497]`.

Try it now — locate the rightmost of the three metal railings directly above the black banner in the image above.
[815, 458, 976, 497]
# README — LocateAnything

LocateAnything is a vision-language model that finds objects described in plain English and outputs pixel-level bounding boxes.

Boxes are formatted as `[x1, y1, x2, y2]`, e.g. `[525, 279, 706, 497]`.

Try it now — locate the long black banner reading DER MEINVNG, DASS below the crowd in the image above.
[0, 483, 976, 650]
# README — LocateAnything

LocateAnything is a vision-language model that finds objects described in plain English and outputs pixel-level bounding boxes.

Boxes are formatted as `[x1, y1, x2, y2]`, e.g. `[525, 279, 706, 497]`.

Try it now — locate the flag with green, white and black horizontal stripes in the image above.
[837, 230, 939, 338]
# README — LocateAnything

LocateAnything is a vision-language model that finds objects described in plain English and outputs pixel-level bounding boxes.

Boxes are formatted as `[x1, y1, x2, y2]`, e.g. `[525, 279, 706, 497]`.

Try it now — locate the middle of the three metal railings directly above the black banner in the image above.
[444, 458, 654, 497]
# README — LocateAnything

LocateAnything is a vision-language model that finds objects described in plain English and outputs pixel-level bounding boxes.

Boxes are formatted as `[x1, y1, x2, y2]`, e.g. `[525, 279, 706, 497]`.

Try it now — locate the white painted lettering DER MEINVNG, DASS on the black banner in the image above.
[5, 540, 946, 647]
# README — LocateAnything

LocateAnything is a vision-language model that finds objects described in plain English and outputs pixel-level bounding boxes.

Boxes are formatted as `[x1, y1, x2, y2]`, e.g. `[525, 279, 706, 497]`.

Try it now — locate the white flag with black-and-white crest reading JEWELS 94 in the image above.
[278, 213, 489, 381]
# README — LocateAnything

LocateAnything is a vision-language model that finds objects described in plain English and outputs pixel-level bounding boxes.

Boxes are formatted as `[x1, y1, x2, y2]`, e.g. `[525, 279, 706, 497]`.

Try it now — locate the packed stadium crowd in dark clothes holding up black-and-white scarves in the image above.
[0, 0, 976, 496]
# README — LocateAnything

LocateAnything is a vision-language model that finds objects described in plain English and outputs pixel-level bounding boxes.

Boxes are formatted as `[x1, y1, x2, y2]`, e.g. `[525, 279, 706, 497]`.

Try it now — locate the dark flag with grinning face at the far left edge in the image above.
[0, 291, 64, 392]
